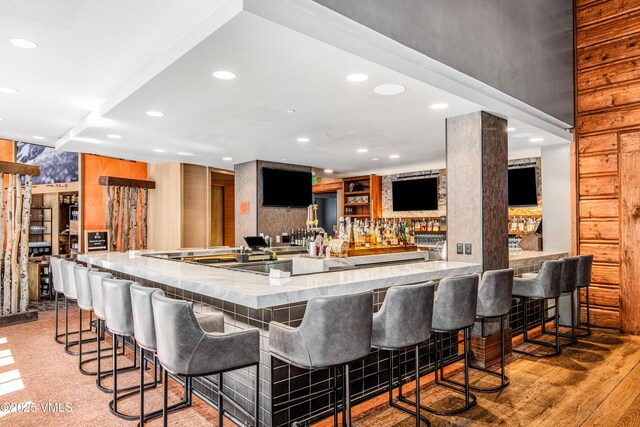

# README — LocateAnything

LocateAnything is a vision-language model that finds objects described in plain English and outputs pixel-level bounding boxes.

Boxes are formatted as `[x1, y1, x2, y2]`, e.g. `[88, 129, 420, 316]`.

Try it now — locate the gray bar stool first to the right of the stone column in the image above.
[512, 261, 564, 357]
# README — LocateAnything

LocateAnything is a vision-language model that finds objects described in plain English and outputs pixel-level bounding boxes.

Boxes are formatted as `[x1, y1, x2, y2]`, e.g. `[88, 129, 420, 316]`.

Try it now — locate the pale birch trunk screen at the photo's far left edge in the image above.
[0, 161, 40, 316]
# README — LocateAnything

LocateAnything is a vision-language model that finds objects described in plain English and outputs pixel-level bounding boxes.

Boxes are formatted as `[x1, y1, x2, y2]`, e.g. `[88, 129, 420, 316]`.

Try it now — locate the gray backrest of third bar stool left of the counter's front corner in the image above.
[102, 279, 135, 337]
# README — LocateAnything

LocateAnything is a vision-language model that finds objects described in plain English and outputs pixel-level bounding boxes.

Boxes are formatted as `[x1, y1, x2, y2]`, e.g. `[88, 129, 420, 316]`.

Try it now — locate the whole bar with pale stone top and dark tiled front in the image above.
[78, 252, 566, 426]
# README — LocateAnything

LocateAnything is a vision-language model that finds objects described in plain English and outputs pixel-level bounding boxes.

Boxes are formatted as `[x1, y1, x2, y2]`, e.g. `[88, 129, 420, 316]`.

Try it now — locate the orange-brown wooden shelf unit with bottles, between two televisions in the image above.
[342, 175, 382, 220]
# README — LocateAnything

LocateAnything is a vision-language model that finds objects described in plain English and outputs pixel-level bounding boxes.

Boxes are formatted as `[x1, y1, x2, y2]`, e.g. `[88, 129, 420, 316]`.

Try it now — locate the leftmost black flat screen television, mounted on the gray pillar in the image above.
[262, 168, 312, 208]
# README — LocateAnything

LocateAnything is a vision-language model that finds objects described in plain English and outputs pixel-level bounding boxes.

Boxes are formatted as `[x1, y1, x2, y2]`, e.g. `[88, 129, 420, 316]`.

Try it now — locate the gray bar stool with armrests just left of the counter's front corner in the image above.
[151, 292, 260, 427]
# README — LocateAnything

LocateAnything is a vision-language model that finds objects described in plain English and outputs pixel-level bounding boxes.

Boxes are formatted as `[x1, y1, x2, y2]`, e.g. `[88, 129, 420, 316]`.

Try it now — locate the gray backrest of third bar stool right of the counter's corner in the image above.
[431, 274, 479, 332]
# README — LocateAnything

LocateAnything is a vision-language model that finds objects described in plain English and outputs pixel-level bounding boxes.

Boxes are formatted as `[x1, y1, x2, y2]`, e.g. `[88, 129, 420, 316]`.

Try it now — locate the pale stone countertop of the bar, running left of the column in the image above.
[78, 252, 480, 309]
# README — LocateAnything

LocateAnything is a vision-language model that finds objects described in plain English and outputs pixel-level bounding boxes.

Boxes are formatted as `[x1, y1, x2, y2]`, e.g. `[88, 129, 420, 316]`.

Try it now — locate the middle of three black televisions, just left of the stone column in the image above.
[391, 177, 438, 212]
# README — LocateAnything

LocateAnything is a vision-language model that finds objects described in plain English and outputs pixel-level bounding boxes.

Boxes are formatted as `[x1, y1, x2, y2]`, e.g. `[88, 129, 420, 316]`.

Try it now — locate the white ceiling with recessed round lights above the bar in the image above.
[0, 0, 566, 173]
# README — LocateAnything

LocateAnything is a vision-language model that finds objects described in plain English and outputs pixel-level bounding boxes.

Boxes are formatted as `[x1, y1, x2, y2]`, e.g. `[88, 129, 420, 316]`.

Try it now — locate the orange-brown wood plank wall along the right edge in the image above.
[575, 0, 640, 334]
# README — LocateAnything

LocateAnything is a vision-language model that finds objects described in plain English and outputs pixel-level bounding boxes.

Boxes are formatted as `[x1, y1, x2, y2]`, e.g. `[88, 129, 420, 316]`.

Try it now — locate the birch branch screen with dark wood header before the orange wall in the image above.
[98, 176, 156, 252]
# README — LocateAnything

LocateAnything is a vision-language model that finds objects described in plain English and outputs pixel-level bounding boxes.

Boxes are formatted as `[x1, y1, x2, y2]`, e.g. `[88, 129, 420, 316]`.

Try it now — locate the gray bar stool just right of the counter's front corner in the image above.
[269, 291, 373, 427]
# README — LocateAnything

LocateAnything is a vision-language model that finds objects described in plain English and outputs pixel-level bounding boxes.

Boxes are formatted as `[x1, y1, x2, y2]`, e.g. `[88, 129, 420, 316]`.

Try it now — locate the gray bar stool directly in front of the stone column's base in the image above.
[442, 268, 513, 393]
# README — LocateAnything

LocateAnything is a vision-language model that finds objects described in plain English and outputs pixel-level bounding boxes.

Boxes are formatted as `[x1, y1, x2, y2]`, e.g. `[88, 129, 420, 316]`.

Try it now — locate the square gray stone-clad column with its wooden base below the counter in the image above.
[446, 111, 511, 366]
